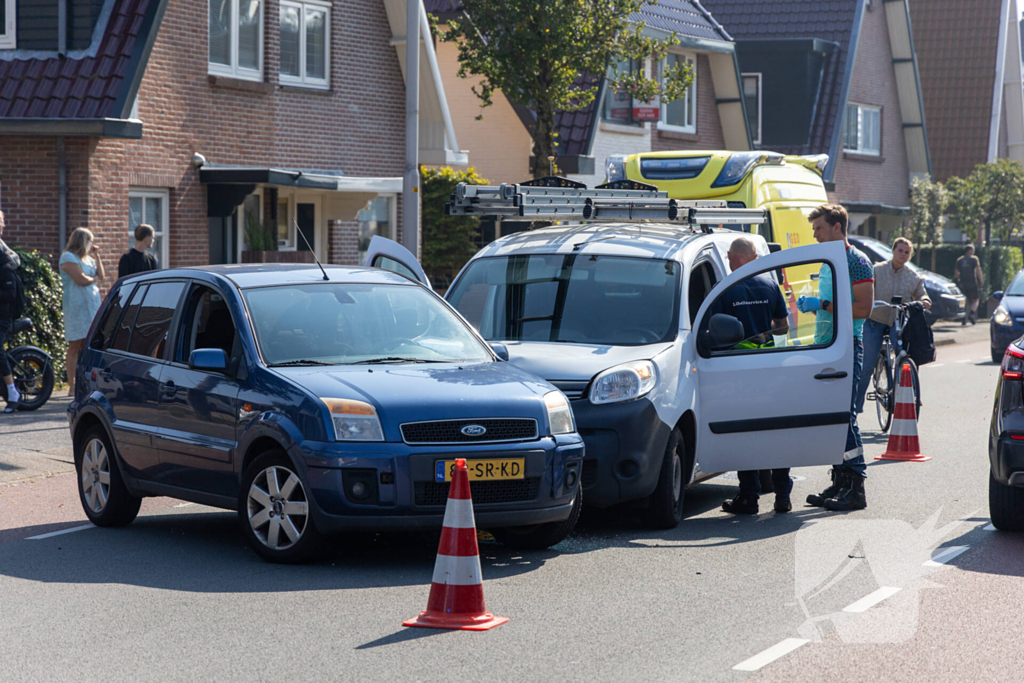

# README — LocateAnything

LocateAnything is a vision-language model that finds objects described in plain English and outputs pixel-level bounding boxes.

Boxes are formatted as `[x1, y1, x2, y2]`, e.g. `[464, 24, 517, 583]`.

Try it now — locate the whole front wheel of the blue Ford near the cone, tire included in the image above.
[238, 450, 324, 564]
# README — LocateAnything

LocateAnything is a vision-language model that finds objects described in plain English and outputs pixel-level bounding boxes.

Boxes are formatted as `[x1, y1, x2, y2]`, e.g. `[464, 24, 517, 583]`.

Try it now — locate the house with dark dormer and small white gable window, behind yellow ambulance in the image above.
[705, 0, 931, 240]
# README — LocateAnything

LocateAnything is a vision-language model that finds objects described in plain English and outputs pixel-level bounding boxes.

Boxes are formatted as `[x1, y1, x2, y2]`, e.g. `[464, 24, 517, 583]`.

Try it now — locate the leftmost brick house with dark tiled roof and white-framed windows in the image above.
[0, 0, 466, 278]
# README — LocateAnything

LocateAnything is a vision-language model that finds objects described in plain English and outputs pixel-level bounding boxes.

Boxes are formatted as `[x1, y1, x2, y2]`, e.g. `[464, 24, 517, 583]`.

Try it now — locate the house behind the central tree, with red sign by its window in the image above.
[427, 0, 751, 193]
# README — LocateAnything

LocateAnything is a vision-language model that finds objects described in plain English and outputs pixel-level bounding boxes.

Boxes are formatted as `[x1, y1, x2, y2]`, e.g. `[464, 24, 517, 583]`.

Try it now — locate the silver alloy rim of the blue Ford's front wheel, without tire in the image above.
[248, 465, 309, 550]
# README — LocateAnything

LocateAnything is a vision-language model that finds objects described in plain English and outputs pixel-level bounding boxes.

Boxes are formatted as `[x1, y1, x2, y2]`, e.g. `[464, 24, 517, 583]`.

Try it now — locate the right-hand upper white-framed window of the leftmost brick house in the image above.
[281, 0, 331, 88]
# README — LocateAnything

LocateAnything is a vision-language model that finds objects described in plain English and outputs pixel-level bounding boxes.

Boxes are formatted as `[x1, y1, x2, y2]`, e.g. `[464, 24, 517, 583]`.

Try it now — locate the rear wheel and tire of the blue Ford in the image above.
[75, 425, 142, 526]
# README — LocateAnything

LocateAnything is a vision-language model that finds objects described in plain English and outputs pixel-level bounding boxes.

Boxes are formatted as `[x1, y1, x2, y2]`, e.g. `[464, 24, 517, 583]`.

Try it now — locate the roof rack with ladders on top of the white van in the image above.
[444, 176, 766, 232]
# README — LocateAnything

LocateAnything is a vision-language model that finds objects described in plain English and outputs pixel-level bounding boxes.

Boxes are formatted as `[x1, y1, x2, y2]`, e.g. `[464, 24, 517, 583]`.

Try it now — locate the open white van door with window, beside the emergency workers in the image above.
[694, 242, 854, 472]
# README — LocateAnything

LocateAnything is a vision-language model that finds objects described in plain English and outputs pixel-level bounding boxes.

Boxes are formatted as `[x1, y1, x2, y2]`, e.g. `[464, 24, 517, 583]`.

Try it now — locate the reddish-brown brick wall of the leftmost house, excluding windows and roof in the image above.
[0, 0, 404, 268]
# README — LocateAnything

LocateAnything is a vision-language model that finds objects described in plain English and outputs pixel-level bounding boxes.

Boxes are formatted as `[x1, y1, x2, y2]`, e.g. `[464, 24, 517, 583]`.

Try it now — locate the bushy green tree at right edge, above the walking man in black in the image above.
[946, 159, 1024, 246]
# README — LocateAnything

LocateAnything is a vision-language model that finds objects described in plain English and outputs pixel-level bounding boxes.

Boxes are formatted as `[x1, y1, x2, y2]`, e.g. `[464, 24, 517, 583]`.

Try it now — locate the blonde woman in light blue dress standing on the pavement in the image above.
[60, 227, 106, 396]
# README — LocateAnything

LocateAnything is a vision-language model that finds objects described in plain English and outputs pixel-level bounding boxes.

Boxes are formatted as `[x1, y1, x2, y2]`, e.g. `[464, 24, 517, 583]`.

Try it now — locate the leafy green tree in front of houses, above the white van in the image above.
[439, 0, 693, 177]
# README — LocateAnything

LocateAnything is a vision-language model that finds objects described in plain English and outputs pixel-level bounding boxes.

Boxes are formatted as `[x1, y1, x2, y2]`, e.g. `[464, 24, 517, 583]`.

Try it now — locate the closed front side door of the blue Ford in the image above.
[156, 284, 245, 496]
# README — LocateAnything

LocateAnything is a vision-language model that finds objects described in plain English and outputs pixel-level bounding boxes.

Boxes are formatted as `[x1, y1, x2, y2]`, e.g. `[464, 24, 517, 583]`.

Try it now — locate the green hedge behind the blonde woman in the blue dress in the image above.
[7, 246, 68, 382]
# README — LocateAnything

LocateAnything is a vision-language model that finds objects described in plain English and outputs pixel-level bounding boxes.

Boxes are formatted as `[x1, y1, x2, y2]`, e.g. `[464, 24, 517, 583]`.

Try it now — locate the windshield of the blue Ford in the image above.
[245, 283, 493, 366]
